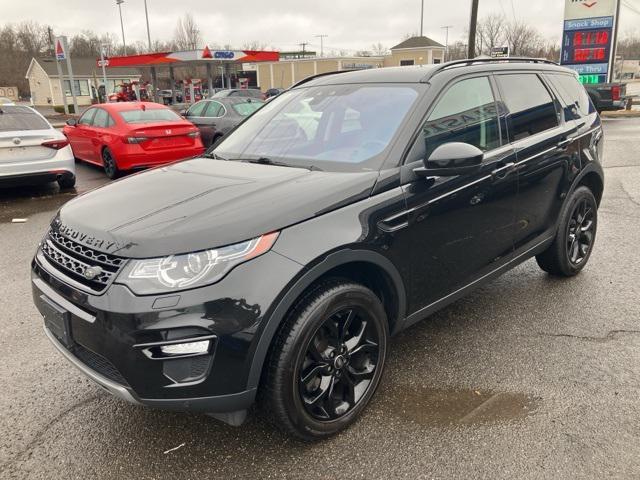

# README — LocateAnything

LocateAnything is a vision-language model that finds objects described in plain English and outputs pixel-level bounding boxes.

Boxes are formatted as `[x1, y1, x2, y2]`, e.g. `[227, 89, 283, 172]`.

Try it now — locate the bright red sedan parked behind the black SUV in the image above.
[64, 102, 205, 178]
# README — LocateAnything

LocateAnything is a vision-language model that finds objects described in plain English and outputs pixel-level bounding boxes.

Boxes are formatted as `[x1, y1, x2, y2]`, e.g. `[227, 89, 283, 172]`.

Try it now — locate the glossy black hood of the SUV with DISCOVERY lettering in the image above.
[53, 158, 378, 258]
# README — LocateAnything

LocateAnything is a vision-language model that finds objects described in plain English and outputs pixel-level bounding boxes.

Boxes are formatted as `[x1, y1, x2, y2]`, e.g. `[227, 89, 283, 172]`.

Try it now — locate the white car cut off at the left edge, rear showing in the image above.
[0, 105, 76, 189]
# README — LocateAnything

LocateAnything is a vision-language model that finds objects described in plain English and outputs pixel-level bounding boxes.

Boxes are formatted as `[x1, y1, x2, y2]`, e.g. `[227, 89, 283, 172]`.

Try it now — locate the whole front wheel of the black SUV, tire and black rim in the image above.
[259, 279, 389, 441]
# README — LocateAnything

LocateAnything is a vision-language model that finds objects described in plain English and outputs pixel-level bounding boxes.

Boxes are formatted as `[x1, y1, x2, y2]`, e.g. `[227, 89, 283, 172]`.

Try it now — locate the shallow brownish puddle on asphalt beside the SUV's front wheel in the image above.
[382, 386, 540, 425]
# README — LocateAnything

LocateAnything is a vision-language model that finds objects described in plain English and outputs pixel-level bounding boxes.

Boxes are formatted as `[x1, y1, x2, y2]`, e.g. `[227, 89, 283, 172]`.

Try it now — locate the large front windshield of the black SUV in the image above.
[215, 84, 420, 171]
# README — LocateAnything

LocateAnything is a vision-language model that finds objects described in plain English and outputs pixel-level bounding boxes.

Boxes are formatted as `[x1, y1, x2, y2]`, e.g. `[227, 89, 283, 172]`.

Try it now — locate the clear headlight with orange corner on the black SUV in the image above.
[117, 232, 278, 295]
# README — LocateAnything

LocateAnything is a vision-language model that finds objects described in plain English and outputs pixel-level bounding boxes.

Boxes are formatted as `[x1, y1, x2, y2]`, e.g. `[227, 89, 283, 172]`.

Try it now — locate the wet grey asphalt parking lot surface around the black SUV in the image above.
[0, 119, 640, 479]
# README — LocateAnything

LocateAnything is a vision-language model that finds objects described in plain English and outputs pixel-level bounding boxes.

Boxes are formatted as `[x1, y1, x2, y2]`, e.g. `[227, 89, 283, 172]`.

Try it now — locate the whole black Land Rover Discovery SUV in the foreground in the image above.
[32, 59, 603, 439]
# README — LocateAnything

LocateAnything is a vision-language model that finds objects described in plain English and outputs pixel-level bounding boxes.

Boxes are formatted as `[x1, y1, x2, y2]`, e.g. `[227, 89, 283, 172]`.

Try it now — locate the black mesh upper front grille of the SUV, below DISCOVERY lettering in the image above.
[40, 230, 126, 293]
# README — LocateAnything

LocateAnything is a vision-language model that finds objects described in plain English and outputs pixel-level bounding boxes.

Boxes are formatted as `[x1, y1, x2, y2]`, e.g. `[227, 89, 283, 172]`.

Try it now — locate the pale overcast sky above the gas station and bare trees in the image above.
[0, 0, 640, 50]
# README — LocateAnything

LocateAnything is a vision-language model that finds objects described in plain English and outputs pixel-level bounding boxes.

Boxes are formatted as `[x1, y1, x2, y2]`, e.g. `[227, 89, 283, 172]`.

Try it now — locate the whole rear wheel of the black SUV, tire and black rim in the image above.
[536, 186, 598, 277]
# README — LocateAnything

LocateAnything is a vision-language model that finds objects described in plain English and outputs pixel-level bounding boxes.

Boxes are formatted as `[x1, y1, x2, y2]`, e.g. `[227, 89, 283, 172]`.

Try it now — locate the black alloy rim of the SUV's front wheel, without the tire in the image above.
[298, 308, 379, 421]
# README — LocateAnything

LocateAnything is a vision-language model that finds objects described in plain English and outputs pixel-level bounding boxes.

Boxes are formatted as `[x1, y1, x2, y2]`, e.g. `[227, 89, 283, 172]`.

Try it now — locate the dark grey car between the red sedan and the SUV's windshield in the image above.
[182, 97, 264, 147]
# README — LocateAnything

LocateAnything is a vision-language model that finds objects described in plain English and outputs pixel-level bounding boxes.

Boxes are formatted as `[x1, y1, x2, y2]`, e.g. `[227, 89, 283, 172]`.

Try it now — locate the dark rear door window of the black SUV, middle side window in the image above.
[496, 73, 558, 142]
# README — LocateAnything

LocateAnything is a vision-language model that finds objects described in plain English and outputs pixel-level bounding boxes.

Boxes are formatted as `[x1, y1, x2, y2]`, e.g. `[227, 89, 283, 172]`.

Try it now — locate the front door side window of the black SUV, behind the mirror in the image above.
[416, 77, 500, 161]
